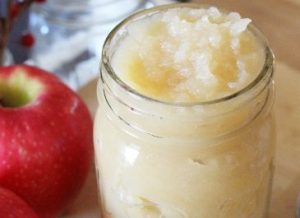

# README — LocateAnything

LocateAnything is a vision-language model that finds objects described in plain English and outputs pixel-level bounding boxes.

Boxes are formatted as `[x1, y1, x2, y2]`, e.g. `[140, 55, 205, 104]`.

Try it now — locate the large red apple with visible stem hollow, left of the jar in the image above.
[0, 65, 92, 218]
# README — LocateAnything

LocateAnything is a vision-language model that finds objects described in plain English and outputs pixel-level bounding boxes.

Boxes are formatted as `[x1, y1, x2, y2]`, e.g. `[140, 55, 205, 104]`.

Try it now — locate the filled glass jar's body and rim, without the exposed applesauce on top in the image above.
[94, 5, 275, 218]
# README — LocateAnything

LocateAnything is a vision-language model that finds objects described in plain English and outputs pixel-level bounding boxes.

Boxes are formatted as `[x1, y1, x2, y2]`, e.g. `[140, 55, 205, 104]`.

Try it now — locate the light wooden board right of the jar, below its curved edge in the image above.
[270, 63, 300, 218]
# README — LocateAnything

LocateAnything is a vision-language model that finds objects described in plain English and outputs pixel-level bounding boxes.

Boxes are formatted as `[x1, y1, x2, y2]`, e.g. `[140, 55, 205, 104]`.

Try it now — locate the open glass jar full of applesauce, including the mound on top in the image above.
[94, 4, 274, 218]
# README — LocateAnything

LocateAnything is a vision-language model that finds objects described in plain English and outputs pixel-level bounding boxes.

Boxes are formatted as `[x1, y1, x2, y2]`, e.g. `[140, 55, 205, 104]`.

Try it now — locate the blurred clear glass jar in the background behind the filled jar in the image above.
[30, 0, 146, 89]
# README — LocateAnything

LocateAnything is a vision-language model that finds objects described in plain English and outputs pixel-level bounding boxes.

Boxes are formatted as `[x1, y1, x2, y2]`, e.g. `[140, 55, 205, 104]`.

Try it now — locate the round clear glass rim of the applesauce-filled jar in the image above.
[100, 3, 275, 107]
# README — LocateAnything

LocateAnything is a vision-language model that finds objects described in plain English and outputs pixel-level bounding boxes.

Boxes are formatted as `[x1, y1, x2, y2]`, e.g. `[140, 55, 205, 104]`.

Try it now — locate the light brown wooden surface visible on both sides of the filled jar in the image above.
[64, 0, 300, 218]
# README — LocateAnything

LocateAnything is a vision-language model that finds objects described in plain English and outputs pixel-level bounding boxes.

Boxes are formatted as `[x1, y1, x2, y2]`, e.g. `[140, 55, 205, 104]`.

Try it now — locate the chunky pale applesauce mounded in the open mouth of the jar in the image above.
[112, 7, 264, 102]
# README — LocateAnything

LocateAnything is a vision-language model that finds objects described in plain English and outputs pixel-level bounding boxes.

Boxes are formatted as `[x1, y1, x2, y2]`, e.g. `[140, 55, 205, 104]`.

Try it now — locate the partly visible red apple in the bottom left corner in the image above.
[0, 187, 38, 218]
